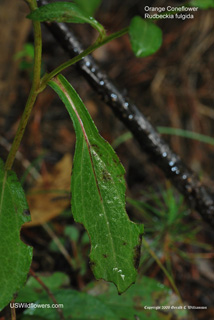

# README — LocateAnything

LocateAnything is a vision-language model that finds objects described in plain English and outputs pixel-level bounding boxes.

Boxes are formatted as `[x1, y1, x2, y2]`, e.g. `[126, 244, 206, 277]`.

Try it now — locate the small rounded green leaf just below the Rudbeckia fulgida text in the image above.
[129, 16, 162, 58]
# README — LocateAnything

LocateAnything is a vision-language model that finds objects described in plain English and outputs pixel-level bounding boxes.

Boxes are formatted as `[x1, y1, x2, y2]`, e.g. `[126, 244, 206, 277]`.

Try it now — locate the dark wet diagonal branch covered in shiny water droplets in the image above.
[38, 0, 214, 226]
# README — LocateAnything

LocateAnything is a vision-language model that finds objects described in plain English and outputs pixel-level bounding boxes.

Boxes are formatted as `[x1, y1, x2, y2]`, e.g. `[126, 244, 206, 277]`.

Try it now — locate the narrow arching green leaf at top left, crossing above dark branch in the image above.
[27, 2, 105, 38]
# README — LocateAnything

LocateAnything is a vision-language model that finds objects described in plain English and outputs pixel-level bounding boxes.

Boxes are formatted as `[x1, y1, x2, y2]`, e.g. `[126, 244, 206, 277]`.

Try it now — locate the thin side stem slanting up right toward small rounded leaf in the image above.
[39, 27, 128, 92]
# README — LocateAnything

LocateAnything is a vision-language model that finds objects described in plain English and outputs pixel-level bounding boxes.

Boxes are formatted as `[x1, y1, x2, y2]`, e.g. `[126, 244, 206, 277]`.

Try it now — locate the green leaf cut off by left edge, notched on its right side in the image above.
[0, 160, 33, 310]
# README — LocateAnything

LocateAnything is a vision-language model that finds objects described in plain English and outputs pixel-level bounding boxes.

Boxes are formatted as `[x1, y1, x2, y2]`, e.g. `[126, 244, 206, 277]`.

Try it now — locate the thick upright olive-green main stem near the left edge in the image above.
[5, 0, 42, 170]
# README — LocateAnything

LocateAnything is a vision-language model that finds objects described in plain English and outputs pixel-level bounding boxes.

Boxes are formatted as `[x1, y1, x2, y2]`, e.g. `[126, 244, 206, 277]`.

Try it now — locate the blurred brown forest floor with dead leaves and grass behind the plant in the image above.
[0, 0, 214, 319]
